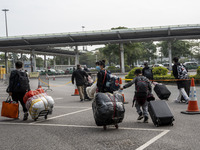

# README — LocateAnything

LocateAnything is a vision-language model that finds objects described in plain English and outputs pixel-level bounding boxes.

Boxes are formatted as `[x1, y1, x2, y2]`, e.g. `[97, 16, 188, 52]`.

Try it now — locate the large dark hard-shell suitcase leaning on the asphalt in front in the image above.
[148, 100, 174, 127]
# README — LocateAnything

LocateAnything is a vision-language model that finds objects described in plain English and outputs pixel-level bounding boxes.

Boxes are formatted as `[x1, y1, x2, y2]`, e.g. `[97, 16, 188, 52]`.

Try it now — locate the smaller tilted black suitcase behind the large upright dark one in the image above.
[154, 84, 171, 100]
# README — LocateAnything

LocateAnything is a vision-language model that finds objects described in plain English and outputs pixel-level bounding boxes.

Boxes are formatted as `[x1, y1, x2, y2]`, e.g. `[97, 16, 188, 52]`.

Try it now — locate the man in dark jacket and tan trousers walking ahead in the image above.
[72, 64, 88, 101]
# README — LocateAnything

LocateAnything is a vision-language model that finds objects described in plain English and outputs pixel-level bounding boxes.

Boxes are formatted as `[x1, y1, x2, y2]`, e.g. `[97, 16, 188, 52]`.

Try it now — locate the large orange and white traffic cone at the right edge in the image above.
[181, 78, 200, 115]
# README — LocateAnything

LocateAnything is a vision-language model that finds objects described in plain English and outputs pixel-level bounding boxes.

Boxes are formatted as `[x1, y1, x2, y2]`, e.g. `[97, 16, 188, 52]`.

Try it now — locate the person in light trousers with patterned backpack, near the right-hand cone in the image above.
[172, 57, 189, 104]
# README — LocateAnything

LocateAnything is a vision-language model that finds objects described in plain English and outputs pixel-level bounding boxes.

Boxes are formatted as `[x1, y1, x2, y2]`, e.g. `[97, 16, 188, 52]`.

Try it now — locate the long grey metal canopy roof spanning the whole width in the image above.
[0, 24, 200, 55]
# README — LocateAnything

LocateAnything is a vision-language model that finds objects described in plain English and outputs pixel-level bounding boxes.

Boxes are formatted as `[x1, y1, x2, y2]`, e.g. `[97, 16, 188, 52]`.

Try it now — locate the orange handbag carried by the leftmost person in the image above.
[1, 96, 19, 118]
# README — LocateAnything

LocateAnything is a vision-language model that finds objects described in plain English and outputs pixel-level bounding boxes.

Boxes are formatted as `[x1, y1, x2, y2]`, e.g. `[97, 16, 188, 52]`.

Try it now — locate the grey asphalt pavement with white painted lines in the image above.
[0, 77, 200, 150]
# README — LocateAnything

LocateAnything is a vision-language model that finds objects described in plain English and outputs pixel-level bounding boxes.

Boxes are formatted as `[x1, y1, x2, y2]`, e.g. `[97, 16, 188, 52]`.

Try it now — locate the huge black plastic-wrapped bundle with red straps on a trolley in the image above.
[92, 93, 125, 126]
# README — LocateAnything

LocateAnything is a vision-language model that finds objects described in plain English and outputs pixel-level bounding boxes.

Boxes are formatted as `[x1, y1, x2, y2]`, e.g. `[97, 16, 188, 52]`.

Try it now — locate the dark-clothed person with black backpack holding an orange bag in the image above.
[7, 61, 30, 120]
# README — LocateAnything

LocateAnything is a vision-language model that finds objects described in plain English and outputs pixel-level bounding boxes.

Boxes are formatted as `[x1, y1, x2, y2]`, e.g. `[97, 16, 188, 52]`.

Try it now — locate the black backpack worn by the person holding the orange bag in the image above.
[14, 71, 29, 92]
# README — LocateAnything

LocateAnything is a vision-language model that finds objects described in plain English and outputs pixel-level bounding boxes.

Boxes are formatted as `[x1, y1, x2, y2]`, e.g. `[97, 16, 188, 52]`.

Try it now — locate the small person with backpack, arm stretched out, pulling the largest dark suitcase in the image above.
[120, 69, 152, 123]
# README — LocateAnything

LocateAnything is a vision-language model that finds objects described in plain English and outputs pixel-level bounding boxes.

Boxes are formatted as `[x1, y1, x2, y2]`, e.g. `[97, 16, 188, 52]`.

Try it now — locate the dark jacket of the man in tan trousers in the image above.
[72, 69, 88, 86]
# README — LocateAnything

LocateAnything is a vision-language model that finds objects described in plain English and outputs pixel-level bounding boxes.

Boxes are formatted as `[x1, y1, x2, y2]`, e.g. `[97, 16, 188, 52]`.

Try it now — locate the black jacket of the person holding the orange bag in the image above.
[6, 70, 30, 93]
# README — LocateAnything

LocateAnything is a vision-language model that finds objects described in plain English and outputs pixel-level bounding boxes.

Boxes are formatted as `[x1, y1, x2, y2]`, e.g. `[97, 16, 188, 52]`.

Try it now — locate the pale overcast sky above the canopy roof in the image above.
[0, 0, 200, 50]
